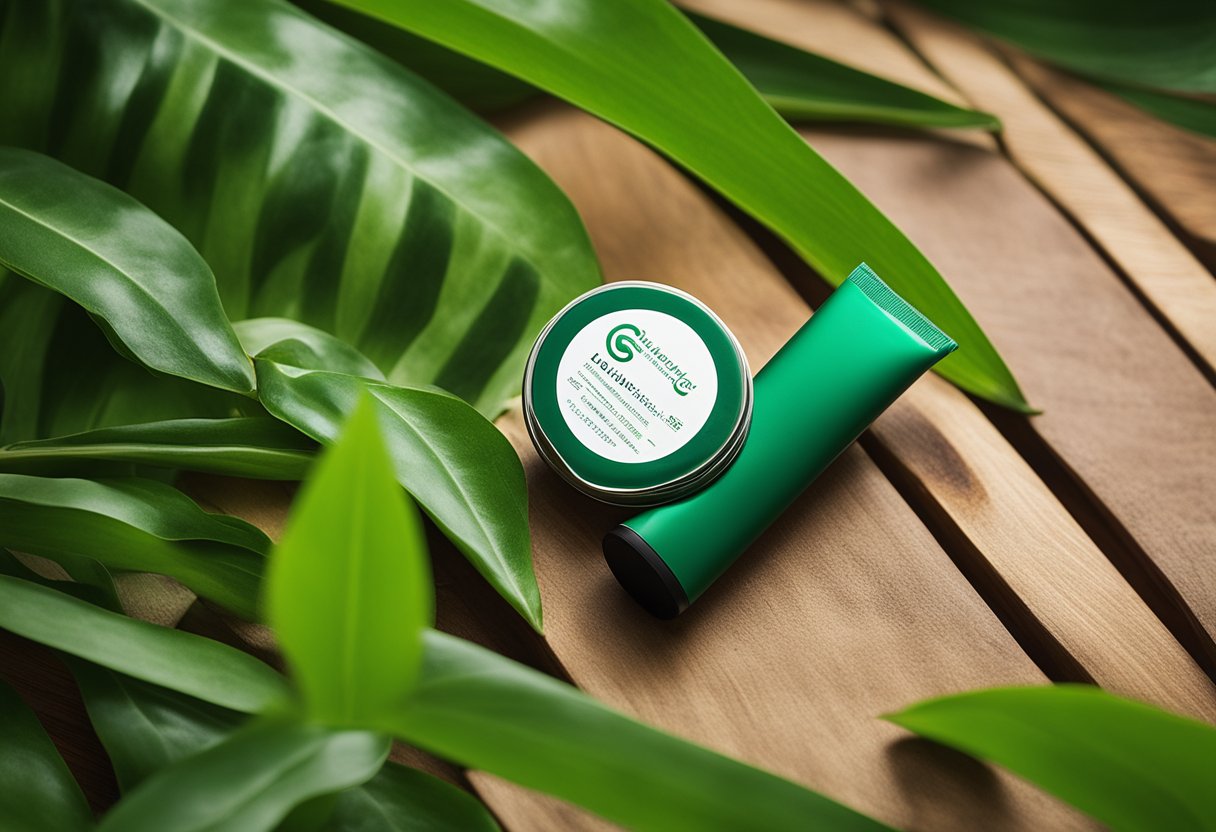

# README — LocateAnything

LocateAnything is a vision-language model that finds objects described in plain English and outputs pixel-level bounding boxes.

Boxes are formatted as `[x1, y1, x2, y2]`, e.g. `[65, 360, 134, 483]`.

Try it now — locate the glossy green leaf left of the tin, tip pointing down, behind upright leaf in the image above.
[255, 358, 541, 630]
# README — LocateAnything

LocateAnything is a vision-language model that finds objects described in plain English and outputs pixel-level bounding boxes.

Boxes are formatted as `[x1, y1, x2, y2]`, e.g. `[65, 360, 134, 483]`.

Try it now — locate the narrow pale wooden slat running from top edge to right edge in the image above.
[888, 1, 1216, 377]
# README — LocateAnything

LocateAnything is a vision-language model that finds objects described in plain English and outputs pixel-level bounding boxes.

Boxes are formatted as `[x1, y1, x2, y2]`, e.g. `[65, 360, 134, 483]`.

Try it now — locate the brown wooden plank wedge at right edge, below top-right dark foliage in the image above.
[1008, 54, 1216, 262]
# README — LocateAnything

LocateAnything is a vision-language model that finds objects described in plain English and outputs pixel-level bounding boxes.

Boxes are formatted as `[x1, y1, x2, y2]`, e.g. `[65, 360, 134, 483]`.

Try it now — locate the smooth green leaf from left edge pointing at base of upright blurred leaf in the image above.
[0, 575, 287, 713]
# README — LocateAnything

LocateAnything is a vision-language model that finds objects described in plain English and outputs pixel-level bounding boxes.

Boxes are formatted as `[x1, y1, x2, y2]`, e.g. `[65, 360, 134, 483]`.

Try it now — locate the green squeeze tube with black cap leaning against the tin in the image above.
[603, 264, 957, 618]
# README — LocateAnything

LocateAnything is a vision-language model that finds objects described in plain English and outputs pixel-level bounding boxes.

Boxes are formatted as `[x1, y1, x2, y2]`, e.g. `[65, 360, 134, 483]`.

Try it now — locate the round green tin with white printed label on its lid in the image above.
[524, 281, 751, 505]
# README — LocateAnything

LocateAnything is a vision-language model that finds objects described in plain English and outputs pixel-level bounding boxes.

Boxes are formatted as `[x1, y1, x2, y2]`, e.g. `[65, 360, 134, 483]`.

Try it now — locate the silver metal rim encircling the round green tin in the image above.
[523, 280, 753, 506]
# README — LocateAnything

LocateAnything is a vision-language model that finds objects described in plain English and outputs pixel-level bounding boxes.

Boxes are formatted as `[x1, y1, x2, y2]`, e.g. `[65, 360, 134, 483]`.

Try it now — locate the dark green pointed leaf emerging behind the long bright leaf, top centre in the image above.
[685, 12, 1001, 130]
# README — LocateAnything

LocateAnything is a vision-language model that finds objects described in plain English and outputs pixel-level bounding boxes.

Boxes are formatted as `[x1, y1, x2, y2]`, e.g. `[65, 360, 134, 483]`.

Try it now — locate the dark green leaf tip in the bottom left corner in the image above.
[0, 682, 92, 832]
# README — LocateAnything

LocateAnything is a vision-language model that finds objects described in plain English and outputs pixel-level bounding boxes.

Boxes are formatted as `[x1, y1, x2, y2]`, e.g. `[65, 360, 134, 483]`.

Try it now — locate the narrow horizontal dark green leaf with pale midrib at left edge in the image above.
[0, 416, 316, 480]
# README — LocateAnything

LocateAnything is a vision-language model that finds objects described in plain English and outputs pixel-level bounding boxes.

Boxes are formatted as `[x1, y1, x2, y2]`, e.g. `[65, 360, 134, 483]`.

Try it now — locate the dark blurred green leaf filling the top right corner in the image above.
[921, 0, 1216, 92]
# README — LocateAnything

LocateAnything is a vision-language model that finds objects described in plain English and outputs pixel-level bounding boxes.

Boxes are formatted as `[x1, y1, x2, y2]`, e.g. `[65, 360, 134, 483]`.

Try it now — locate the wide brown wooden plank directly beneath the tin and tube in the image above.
[473, 106, 1086, 830]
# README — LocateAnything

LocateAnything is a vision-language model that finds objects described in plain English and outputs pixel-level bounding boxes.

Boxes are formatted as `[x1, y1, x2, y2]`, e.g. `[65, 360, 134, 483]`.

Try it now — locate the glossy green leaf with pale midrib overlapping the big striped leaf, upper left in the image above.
[0, 147, 253, 393]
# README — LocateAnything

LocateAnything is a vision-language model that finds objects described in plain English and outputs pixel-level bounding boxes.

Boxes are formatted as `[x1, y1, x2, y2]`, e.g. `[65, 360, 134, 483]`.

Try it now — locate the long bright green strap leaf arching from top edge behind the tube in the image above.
[321, 0, 1026, 409]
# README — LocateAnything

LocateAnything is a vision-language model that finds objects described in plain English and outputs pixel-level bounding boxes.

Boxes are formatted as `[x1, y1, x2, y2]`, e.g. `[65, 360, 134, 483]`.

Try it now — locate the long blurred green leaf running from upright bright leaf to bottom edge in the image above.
[385, 630, 886, 832]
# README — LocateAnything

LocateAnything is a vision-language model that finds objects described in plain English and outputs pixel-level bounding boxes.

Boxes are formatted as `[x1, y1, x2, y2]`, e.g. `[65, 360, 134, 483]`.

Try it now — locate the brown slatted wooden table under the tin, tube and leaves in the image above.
[0, 0, 1216, 831]
